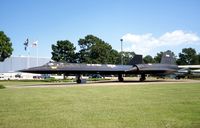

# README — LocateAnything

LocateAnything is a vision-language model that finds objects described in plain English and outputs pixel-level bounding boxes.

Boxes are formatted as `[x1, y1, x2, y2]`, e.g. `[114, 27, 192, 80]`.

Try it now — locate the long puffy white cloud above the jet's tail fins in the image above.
[122, 30, 200, 54]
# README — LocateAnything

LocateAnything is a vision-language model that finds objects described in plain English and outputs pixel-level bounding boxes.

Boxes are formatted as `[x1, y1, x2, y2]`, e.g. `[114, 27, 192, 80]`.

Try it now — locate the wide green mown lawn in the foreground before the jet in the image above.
[0, 83, 200, 128]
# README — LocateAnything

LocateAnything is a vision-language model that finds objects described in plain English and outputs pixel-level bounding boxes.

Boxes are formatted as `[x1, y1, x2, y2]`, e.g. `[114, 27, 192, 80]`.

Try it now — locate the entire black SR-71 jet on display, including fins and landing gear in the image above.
[20, 51, 178, 83]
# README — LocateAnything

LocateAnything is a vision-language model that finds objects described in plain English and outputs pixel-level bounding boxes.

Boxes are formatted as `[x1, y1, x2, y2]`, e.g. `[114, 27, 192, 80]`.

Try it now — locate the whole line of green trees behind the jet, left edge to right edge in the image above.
[0, 31, 200, 65]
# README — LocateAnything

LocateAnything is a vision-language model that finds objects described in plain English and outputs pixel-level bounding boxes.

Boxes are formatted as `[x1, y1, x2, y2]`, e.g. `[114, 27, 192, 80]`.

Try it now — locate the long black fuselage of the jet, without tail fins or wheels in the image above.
[20, 62, 177, 75]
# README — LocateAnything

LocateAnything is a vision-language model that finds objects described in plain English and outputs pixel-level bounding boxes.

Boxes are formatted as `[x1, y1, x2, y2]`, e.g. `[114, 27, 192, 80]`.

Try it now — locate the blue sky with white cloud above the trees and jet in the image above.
[0, 0, 200, 58]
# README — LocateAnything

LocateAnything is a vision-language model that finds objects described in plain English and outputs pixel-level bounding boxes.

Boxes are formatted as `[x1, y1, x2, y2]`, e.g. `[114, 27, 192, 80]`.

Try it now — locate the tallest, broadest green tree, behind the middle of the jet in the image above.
[78, 35, 118, 64]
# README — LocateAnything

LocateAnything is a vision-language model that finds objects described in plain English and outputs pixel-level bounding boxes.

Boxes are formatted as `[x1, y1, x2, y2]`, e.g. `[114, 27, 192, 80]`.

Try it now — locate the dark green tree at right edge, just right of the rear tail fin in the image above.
[177, 48, 199, 65]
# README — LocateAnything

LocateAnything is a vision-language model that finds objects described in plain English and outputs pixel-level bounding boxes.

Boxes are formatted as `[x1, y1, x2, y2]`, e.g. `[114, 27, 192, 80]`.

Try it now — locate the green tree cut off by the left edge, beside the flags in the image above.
[0, 31, 13, 62]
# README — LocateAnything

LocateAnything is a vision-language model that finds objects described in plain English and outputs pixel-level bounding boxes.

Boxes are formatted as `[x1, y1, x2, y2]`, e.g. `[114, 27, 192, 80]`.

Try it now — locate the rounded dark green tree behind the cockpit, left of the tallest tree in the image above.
[51, 40, 76, 63]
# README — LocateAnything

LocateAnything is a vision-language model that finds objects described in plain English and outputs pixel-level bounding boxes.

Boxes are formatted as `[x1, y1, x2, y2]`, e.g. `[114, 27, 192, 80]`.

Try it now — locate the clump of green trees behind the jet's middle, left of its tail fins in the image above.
[51, 35, 135, 64]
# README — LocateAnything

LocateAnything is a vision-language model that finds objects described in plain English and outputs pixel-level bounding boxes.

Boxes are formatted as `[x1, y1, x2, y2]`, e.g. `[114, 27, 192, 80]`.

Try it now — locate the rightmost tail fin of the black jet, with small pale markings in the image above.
[160, 50, 176, 64]
